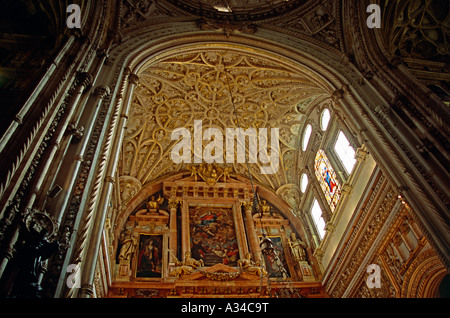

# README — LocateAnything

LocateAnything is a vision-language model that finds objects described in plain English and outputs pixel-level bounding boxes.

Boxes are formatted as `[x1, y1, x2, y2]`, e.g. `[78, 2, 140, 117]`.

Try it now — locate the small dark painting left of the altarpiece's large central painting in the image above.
[136, 234, 163, 278]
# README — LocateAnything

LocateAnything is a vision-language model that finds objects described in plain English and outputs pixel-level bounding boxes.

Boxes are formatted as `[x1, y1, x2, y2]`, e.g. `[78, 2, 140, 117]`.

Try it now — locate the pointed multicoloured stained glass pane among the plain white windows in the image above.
[314, 149, 341, 212]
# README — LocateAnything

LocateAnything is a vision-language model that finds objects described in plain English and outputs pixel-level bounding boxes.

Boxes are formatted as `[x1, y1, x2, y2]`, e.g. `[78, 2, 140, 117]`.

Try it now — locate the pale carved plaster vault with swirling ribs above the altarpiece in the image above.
[120, 48, 324, 205]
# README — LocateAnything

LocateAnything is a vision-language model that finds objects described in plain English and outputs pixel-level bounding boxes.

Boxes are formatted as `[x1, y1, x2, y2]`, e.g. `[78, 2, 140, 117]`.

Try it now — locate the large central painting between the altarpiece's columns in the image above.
[189, 206, 239, 266]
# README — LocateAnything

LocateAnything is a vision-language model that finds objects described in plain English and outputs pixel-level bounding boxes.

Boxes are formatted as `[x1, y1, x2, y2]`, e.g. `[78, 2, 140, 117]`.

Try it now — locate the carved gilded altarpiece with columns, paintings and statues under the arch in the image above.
[109, 165, 324, 297]
